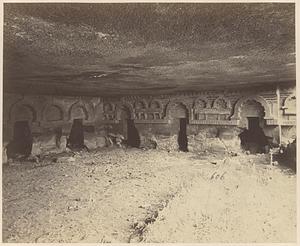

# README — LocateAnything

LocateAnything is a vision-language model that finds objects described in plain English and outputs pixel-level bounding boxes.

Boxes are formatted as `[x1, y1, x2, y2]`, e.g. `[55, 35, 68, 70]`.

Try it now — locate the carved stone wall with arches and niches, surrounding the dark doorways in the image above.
[3, 82, 296, 154]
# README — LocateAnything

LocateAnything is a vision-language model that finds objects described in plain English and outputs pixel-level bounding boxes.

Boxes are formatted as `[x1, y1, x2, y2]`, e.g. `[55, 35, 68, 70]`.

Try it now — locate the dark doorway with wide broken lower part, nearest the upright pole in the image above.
[239, 117, 268, 154]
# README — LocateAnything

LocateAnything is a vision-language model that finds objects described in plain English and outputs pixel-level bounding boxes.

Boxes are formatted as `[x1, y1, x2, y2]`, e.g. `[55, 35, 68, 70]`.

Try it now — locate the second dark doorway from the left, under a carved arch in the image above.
[67, 119, 84, 149]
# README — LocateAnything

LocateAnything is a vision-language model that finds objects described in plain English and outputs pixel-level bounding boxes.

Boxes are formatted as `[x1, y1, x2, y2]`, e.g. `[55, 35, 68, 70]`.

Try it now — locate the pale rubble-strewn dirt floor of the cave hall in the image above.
[3, 148, 296, 243]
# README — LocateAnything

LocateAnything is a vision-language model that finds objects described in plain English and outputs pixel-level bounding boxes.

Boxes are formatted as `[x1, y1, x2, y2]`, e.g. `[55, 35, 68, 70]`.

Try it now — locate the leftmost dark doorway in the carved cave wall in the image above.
[7, 121, 32, 158]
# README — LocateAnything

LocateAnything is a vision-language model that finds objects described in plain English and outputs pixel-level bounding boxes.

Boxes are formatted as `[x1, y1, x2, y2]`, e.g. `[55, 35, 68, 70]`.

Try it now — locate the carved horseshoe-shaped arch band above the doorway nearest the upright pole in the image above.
[230, 96, 273, 120]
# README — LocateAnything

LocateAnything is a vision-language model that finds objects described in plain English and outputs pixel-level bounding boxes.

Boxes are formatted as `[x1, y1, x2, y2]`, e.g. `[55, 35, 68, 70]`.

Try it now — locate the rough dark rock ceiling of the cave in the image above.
[4, 3, 296, 95]
